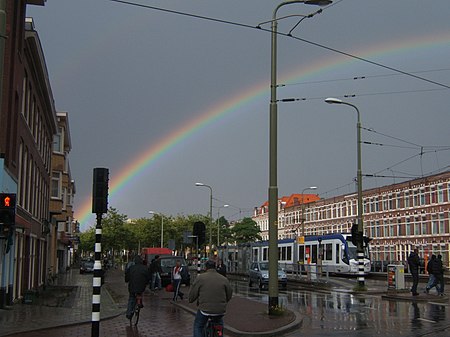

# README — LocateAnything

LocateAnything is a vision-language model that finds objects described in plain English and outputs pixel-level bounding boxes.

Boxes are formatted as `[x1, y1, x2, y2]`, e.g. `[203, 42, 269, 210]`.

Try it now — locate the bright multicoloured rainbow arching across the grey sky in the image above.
[75, 33, 450, 228]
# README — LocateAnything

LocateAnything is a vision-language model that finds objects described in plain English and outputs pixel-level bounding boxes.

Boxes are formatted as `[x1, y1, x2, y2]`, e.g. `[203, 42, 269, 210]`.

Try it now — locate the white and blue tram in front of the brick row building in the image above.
[219, 233, 371, 275]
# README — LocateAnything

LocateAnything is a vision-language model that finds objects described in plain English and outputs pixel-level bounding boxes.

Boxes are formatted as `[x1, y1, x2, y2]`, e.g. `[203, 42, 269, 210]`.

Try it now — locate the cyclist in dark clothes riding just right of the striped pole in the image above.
[125, 255, 150, 319]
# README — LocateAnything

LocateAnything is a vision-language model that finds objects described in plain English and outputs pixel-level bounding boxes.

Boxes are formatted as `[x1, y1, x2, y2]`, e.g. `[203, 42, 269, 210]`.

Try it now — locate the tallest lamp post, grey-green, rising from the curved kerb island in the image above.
[269, 0, 332, 315]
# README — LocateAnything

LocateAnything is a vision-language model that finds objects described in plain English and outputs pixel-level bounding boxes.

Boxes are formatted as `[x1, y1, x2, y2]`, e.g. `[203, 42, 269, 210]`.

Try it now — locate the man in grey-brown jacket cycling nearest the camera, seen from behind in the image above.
[189, 260, 233, 337]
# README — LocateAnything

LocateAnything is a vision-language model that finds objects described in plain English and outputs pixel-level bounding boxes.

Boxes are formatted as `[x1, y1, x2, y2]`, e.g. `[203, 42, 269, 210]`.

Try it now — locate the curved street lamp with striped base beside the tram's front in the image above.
[325, 97, 364, 287]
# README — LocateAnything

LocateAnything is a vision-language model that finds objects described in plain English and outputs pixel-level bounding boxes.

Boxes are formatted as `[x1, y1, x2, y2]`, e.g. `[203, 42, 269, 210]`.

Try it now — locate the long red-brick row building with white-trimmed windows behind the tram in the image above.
[253, 171, 450, 267]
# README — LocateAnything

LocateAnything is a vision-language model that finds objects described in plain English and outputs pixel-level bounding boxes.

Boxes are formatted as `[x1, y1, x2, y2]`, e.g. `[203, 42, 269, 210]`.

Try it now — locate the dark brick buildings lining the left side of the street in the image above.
[0, 0, 75, 307]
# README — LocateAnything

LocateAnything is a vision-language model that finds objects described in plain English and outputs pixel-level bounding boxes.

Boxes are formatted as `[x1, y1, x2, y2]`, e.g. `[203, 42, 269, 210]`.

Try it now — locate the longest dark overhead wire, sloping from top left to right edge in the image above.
[108, 0, 450, 89]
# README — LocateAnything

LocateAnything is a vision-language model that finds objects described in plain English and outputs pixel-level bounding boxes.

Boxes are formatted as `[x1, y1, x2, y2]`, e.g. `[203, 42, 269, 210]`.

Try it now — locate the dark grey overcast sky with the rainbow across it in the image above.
[27, 0, 450, 229]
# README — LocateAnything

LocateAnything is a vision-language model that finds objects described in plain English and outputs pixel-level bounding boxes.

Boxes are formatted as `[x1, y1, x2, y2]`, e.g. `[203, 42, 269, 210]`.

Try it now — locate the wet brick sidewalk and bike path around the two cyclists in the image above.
[0, 269, 302, 337]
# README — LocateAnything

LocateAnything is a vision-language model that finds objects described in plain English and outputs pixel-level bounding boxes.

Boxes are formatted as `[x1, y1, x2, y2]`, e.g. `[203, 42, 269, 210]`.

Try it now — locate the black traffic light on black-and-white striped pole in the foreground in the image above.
[91, 168, 109, 337]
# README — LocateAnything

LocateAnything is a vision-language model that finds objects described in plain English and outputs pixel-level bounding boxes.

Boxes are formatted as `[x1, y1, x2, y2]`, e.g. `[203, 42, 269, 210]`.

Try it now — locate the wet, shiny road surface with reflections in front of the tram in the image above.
[234, 276, 450, 337]
